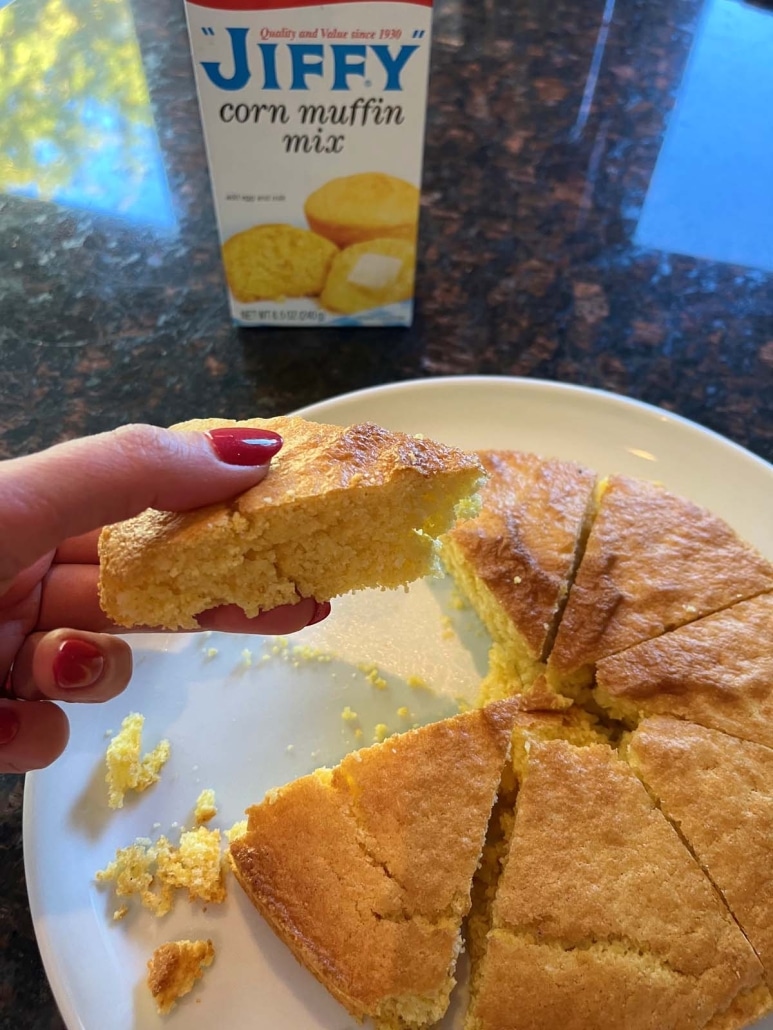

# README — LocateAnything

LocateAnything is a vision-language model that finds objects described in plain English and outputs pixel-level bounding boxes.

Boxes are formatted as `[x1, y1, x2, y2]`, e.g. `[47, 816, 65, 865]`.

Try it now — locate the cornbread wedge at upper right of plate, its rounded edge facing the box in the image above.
[548, 476, 773, 693]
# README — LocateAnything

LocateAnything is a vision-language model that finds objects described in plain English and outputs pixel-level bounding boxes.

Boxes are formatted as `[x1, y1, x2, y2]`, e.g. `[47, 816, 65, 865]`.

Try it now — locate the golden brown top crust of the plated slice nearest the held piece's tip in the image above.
[444, 450, 596, 661]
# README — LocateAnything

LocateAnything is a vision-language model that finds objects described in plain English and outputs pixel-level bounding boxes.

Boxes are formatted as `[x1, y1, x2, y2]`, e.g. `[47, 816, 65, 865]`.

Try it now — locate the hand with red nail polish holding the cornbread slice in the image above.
[0, 425, 330, 773]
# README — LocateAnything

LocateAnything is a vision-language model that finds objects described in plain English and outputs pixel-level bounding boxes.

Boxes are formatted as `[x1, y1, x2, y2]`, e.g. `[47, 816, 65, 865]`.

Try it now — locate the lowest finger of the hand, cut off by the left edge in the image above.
[0, 699, 70, 773]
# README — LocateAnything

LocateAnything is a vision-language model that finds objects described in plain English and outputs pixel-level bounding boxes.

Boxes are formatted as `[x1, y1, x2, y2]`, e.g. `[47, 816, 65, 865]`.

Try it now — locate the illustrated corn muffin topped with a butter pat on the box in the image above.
[321, 239, 416, 315]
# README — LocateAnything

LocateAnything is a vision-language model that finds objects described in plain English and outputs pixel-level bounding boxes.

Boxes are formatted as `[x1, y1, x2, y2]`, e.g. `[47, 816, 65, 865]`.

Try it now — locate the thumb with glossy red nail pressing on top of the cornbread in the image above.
[0, 425, 282, 582]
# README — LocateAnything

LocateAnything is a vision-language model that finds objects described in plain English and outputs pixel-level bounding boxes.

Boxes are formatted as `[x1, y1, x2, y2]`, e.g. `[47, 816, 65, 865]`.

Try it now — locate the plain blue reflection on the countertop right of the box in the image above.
[634, 0, 773, 271]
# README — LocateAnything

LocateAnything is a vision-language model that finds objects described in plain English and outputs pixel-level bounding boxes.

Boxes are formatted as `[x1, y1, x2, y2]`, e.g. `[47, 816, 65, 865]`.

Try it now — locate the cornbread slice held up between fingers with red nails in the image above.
[100, 416, 483, 629]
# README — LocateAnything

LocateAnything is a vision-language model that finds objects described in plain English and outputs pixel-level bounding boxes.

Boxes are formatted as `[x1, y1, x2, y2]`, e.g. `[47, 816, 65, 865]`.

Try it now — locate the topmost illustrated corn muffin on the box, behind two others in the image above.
[304, 172, 418, 247]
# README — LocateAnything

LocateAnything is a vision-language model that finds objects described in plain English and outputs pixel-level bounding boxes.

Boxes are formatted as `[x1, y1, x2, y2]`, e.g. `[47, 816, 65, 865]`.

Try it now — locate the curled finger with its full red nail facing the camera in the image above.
[9, 629, 132, 702]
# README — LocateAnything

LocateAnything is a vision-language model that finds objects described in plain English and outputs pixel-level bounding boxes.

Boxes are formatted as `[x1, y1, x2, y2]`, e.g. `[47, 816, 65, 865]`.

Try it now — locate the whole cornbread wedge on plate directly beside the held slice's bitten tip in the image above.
[441, 450, 596, 697]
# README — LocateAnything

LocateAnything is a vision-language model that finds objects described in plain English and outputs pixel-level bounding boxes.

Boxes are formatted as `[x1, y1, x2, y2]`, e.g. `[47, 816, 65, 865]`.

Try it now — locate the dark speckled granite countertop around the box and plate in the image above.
[0, 0, 773, 1030]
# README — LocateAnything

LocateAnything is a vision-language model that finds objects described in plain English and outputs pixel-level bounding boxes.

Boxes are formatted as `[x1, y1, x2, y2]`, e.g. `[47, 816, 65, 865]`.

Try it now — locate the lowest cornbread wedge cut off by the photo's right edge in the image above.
[628, 717, 773, 986]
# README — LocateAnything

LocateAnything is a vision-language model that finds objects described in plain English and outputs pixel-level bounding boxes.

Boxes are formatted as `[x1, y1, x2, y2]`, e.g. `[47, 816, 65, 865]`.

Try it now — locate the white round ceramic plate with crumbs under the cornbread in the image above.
[24, 377, 773, 1030]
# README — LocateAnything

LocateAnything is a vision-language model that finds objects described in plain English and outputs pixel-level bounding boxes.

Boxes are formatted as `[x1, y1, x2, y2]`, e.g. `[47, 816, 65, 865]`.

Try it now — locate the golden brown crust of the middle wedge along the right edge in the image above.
[594, 593, 773, 747]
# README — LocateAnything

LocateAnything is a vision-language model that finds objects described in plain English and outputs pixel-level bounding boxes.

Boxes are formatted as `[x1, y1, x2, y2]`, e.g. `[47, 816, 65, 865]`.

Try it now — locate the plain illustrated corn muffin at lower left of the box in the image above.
[223, 225, 338, 304]
